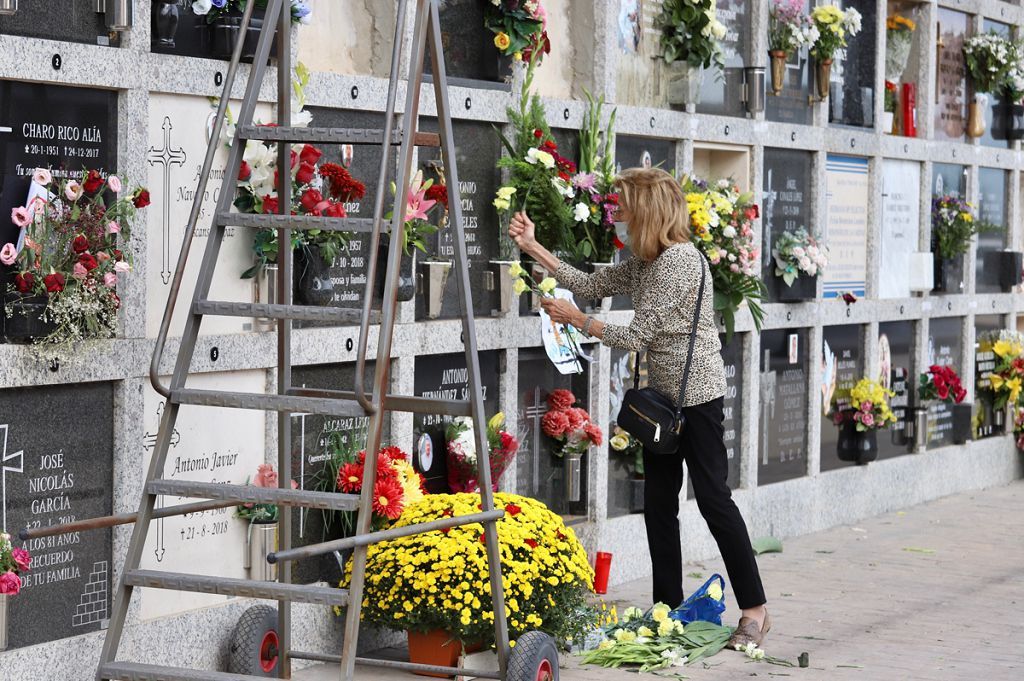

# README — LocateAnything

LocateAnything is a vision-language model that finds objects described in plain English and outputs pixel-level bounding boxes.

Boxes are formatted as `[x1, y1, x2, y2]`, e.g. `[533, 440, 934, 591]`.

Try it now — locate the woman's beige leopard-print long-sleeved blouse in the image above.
[555, 243, 725, 407]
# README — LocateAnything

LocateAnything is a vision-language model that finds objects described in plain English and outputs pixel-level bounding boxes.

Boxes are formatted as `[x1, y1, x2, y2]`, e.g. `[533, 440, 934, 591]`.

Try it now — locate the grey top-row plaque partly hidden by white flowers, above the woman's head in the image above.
[697, 0, 752, 116]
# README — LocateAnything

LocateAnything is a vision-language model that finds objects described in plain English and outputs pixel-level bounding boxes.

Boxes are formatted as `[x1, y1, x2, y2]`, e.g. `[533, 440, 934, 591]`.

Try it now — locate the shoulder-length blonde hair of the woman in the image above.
[615, 168, 690, 262]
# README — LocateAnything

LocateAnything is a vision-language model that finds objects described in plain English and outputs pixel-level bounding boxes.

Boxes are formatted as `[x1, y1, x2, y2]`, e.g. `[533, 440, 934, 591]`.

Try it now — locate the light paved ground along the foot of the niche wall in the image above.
[295, 481, 1024, 681]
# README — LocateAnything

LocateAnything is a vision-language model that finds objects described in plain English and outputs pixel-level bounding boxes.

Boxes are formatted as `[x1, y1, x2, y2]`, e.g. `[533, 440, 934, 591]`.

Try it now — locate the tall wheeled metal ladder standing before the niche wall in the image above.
[22, 0, 520, 681]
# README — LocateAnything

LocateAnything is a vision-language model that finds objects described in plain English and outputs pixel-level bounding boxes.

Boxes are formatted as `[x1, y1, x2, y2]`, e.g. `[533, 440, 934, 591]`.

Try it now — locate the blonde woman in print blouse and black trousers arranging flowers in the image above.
[509, 168, 770, 647]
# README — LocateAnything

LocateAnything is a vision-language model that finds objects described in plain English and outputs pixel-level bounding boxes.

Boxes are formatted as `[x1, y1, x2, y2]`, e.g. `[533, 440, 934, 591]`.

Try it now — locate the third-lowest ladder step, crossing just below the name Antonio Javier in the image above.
[146, 479, 359, 511]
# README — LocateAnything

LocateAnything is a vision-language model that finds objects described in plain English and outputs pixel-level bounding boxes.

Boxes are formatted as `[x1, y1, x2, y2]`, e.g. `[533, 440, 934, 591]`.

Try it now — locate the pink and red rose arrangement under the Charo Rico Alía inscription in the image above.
[0, 168, 150, 347]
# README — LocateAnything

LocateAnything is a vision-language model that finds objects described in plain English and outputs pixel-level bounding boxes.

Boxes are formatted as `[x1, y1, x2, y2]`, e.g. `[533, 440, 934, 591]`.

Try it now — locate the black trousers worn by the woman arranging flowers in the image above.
[643, 397, 765, 608]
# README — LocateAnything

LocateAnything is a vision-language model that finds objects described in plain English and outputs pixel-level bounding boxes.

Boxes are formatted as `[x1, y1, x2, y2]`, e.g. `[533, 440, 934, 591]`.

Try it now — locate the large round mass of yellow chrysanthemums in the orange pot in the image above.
[341, 494, 594, 645]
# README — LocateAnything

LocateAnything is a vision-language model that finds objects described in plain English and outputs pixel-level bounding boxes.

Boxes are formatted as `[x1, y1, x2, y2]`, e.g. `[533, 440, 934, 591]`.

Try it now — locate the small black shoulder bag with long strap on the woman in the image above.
[615, 262, 706, 455]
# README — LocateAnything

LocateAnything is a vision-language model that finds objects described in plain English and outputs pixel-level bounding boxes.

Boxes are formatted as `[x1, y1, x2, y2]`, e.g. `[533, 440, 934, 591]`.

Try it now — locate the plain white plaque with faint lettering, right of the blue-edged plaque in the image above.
[879, 159, 921, 298]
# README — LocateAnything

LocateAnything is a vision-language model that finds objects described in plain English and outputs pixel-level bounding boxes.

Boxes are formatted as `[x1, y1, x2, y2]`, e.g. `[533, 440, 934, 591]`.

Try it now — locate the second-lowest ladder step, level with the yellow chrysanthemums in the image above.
[125, 569, 348, 606]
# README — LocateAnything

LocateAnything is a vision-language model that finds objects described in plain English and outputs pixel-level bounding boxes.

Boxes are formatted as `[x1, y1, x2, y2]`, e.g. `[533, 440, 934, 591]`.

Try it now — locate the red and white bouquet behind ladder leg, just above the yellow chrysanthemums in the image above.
[444, 412, 519, 493]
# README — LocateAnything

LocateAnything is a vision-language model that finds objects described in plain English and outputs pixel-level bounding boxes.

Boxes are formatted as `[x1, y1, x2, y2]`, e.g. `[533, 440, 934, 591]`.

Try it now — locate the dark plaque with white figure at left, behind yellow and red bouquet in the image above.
[817, 325, 864, 471]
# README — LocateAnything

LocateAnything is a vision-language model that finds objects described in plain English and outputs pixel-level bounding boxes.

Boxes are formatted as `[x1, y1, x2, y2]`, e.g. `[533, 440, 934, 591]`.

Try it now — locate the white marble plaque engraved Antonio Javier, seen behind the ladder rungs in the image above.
[138, 371, 268, 620]
